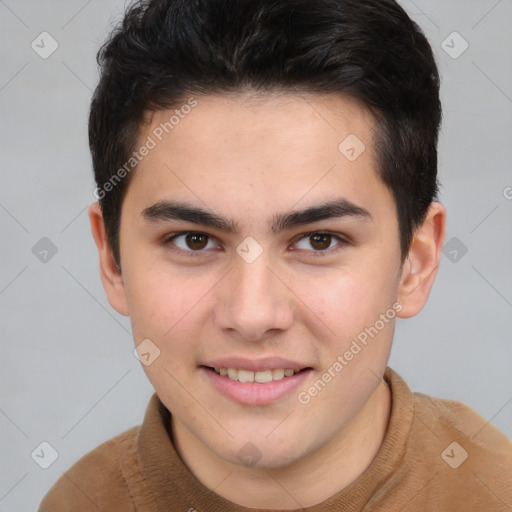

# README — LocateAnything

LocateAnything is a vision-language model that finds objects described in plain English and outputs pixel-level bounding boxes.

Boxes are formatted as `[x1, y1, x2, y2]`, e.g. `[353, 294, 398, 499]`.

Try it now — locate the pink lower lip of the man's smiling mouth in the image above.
[199, 366, 312, 405]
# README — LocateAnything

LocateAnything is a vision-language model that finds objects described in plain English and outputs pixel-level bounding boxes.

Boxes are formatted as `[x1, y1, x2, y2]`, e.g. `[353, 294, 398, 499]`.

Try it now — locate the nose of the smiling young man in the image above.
[214, 253, 294, 341]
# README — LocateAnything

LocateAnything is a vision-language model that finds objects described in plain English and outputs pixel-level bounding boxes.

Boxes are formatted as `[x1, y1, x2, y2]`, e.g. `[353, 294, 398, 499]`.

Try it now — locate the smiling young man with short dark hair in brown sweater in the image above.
[40, 0, 512, 512]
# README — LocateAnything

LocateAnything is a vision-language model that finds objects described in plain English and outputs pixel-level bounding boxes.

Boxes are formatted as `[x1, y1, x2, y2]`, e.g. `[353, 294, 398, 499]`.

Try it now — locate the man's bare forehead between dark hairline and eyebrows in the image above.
[128, 92, 389, 221]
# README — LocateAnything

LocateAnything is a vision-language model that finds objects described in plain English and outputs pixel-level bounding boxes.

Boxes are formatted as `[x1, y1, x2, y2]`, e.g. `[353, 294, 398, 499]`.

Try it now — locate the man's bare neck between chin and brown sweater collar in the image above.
[172, 381, 391, 510]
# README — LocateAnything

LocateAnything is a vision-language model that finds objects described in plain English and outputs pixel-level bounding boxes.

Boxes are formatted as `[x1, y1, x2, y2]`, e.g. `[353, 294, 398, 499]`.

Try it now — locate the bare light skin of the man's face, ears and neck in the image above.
[89, 93, 446, 509]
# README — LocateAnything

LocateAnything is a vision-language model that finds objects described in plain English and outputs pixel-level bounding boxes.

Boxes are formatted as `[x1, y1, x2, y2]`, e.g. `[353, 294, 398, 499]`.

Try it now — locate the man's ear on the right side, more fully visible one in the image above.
[397, 202, 446, 318]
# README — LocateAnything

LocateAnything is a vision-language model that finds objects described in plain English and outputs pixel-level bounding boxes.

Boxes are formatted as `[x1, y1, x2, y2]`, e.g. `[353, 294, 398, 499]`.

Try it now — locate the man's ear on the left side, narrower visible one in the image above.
[89, 203, 129, 316]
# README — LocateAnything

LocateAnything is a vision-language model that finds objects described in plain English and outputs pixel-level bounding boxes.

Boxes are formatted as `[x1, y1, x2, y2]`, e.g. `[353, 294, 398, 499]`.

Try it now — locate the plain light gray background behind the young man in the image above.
[0, 0, 512, 512]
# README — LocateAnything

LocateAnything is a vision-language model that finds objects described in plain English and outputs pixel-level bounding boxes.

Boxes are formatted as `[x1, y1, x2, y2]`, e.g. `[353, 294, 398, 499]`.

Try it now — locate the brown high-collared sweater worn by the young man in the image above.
[39, 369, 512, 512]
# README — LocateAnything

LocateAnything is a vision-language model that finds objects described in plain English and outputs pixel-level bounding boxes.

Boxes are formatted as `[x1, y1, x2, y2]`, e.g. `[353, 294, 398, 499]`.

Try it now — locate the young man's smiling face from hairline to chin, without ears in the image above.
[115, 94, 401, 467]
